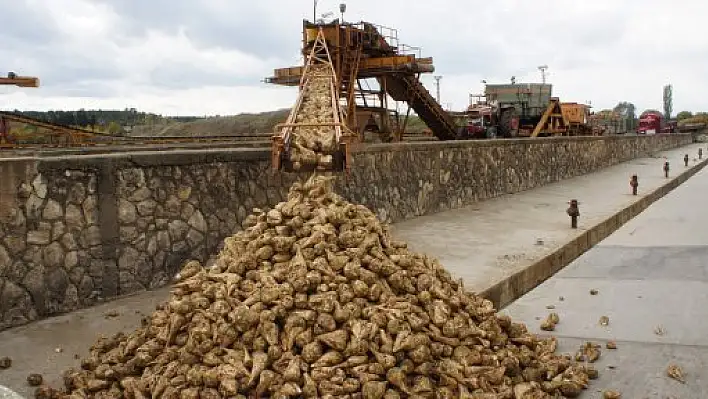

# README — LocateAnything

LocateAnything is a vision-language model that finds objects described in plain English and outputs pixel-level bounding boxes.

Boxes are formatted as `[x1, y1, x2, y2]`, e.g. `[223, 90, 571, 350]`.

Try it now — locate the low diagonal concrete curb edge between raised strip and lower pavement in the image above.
[480, 153, 708, 309]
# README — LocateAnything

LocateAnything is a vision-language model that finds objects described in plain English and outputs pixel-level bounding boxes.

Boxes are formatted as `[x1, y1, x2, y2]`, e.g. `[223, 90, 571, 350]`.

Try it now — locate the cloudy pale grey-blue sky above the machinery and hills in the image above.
[0, 0, 708, 115]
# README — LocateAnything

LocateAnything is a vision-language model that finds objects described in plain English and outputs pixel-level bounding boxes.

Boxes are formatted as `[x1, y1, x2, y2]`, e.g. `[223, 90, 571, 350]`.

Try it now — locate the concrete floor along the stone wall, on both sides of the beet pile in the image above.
[0, 141, 706, 397]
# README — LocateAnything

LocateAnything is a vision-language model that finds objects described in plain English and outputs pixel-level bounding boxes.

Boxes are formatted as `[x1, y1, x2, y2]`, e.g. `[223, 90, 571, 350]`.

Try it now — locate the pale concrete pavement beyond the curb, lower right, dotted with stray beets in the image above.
[503, 158, 708, 399]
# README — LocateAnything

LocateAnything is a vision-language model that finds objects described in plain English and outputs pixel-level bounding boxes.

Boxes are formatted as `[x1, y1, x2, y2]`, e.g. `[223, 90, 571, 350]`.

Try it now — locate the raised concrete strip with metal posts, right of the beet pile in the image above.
[393, 144, 708, 292]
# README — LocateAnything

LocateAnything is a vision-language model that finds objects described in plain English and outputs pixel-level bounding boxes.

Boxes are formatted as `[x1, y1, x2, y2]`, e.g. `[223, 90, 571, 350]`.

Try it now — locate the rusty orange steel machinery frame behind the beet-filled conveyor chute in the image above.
[265, 21, 457, 141]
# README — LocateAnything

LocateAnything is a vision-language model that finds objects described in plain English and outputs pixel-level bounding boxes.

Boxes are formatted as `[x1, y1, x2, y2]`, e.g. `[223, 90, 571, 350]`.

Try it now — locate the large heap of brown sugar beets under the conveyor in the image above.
[37, 175, 597, 399]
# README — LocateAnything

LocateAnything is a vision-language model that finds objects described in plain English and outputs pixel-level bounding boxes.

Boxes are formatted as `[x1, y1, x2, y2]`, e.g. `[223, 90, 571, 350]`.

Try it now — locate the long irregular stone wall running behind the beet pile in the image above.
[0, 135, 692, 329]
